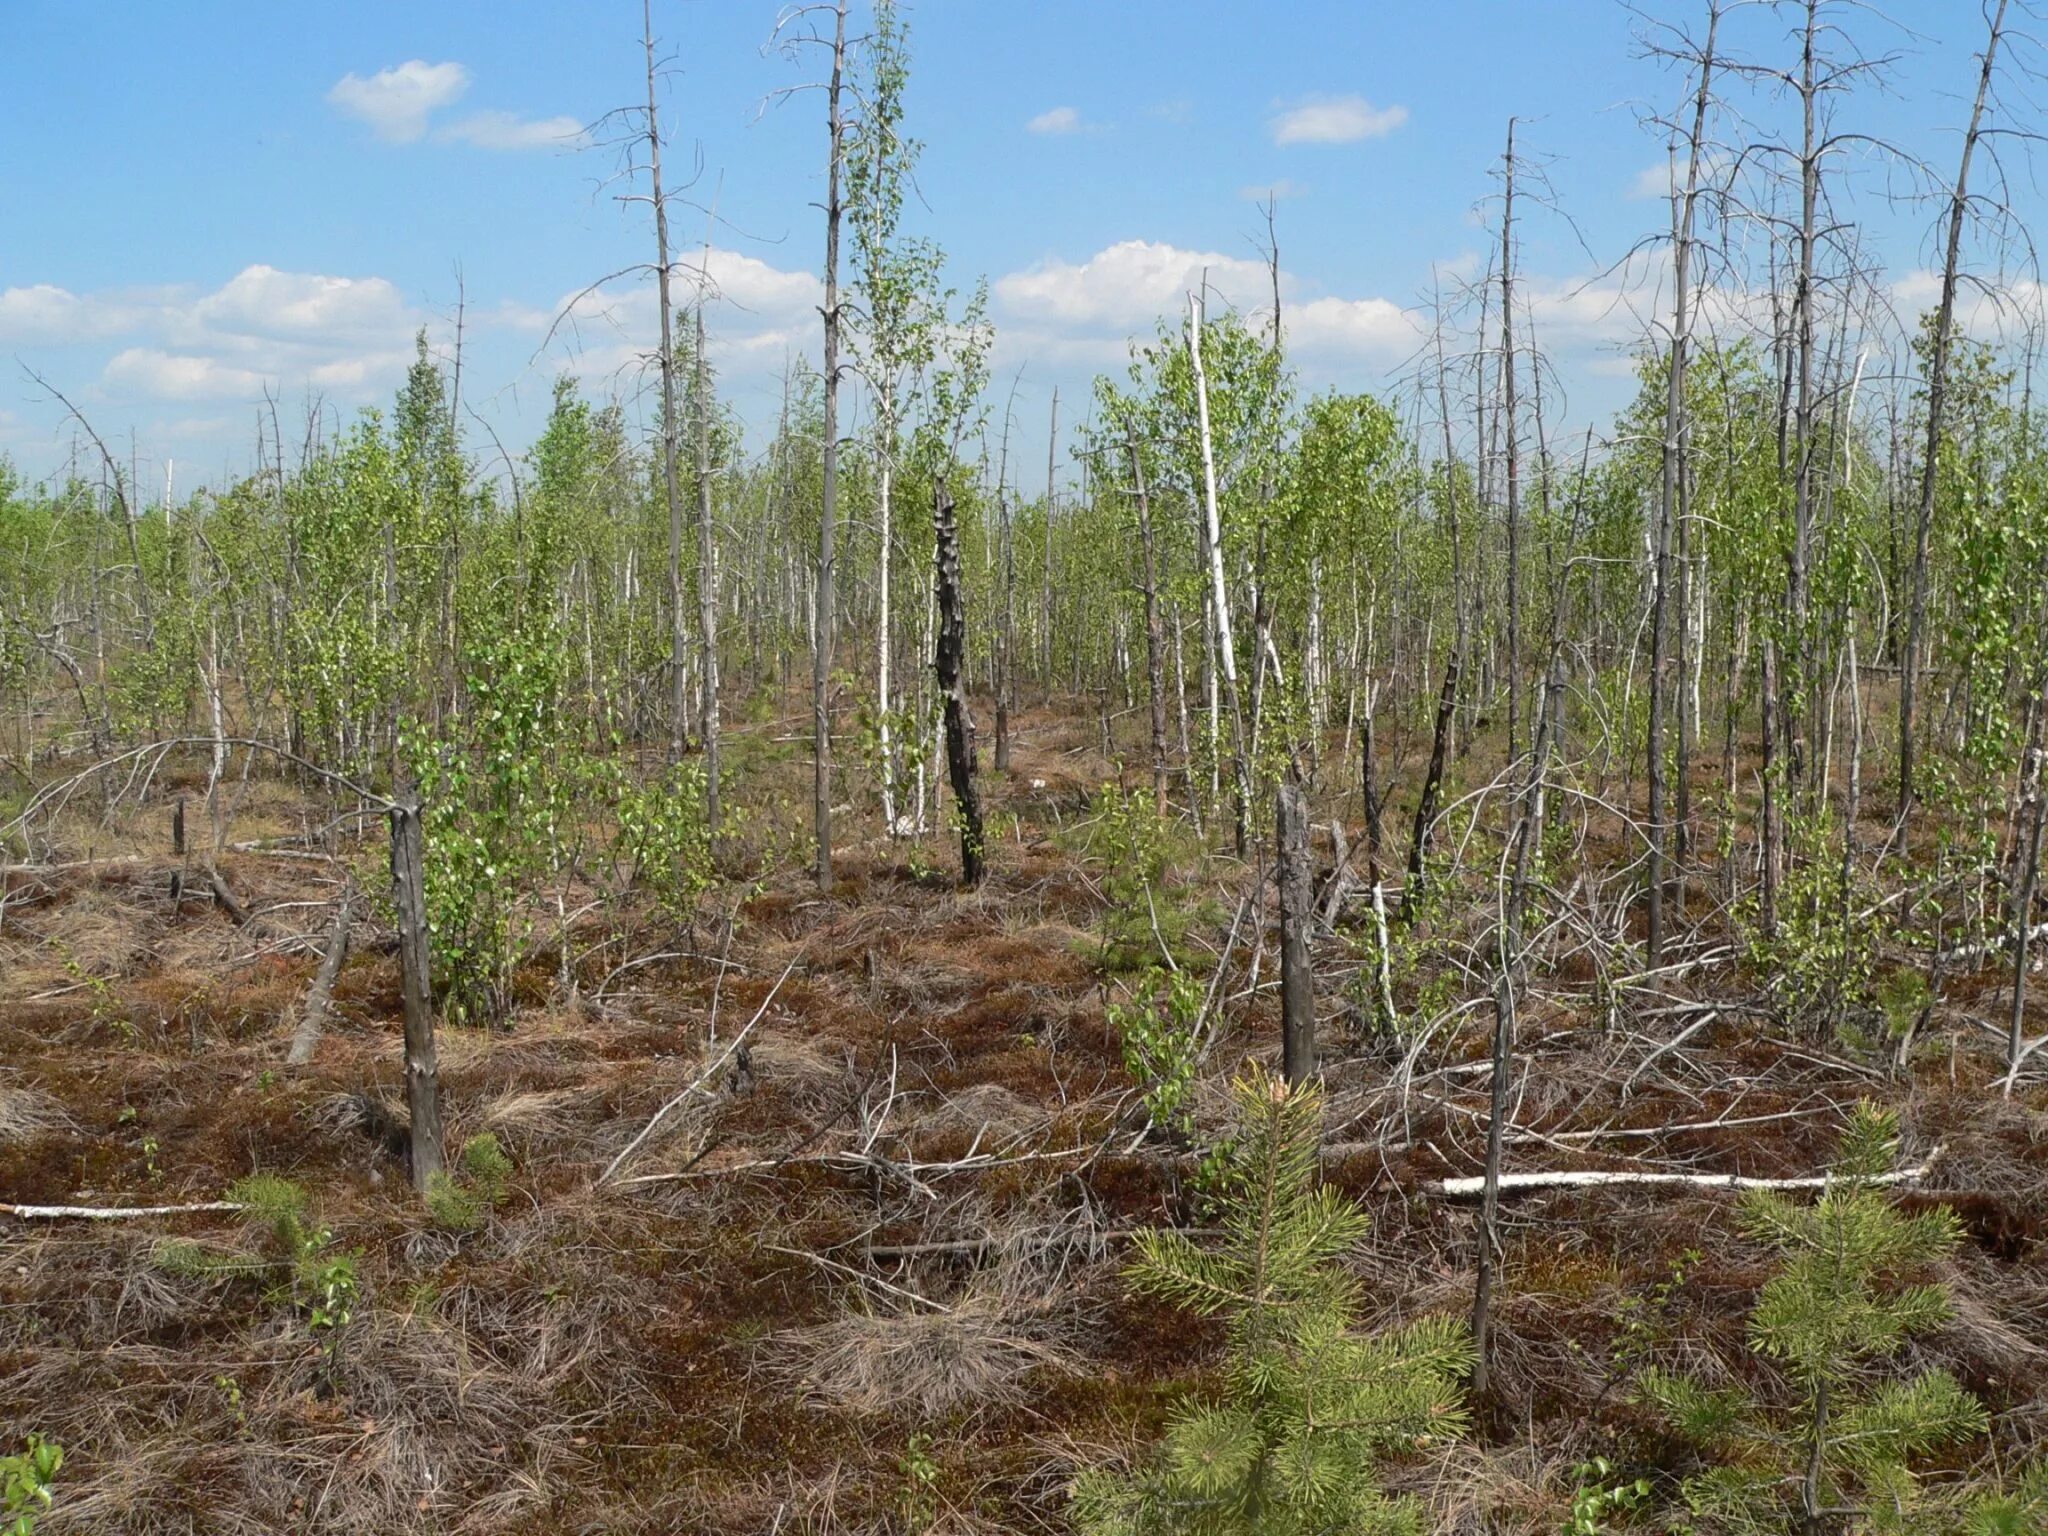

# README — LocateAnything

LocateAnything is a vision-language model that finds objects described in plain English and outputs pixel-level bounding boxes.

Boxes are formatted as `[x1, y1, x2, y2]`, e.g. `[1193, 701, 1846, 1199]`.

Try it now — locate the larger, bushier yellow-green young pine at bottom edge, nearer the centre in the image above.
[1073, 1071, 1473, 1536]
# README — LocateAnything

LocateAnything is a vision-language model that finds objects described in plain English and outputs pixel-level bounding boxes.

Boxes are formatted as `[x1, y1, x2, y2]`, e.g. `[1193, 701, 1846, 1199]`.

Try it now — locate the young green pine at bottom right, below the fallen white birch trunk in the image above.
[1640, 1104, 1989, 1534]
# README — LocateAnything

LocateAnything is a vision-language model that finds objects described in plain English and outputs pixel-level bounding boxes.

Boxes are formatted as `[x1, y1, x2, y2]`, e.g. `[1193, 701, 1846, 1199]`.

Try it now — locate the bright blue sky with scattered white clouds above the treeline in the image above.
[0, 0, 2038, 489]
